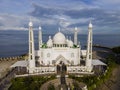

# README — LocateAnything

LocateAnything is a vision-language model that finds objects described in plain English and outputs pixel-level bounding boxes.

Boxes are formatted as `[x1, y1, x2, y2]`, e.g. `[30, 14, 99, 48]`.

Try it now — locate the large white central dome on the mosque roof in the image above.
[53, 32, 66, 44]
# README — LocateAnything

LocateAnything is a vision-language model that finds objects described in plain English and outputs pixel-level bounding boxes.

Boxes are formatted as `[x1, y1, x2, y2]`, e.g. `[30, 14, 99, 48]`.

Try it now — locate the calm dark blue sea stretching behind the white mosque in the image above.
[0, 30, 120, 57]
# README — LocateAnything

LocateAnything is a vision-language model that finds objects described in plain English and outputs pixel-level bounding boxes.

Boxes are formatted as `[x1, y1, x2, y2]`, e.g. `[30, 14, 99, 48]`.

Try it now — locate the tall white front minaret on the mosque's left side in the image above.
[29, 21, 35, 73]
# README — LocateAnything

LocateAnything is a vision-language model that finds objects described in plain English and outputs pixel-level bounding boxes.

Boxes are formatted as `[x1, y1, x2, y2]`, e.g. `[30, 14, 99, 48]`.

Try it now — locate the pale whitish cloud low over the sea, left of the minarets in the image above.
[0, 14, 29, 30]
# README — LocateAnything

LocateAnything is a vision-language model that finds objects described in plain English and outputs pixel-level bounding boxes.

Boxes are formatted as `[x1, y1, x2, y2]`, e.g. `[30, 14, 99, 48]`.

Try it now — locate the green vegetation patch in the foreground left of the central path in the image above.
[9, 76, 55, 90]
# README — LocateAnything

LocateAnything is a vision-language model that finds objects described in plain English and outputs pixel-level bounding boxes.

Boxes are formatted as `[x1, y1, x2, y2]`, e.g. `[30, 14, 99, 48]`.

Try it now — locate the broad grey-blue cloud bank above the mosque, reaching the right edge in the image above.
[30, 4, 120, 32]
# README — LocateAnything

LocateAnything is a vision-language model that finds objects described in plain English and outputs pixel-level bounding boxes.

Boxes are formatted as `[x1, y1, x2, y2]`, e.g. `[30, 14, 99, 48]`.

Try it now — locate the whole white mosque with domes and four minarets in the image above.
[28, 21, 93, 73]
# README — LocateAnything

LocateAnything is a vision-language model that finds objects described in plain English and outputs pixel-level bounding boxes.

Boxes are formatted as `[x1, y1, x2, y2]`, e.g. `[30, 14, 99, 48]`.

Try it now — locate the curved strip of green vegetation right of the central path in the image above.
[70, 55, 117, 90]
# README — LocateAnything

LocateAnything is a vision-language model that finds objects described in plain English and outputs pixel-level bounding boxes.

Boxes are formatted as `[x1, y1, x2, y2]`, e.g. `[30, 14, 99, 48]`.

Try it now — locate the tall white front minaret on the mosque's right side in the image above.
[86, 22, 93, 71]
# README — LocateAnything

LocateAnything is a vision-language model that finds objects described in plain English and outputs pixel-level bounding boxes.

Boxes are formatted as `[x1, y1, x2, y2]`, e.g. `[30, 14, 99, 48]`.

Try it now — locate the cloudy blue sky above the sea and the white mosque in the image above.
[0, 0, 120, 34]
